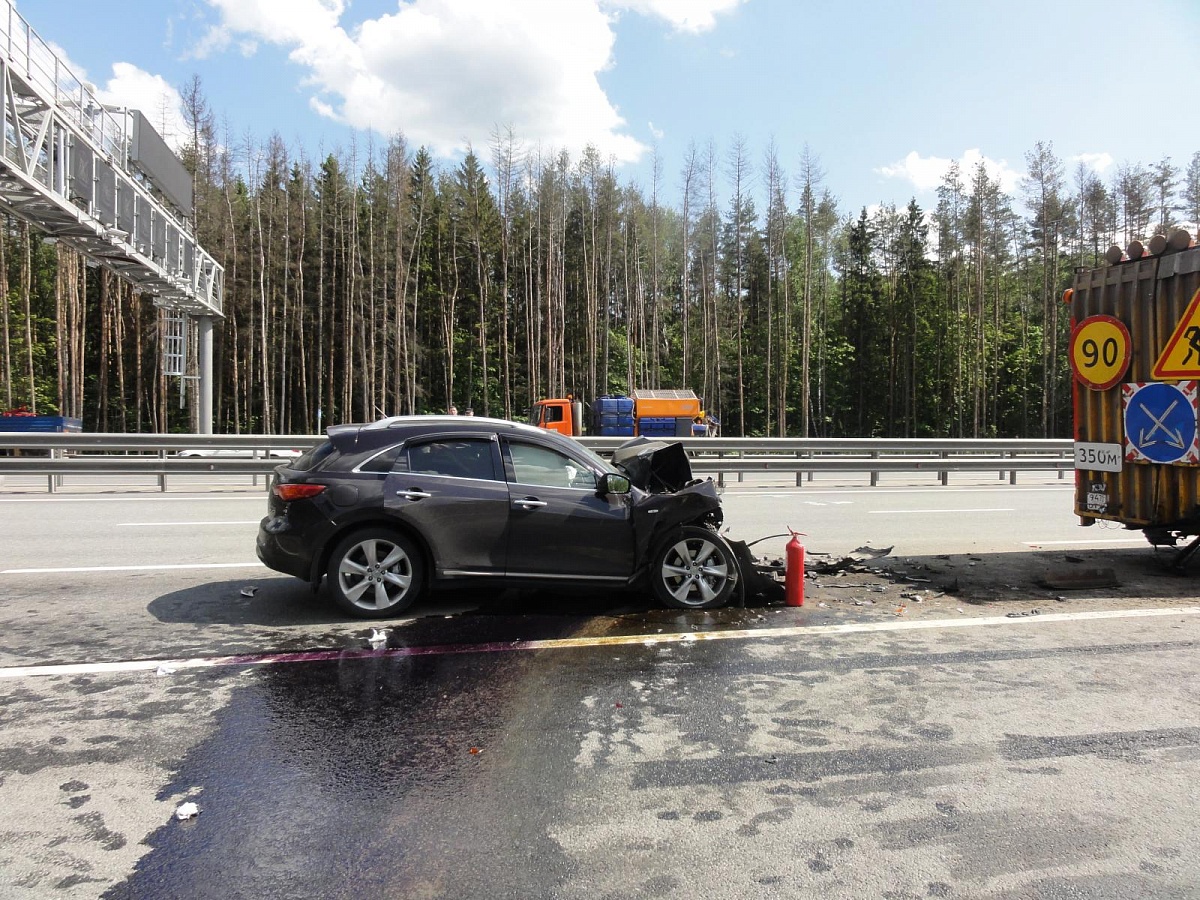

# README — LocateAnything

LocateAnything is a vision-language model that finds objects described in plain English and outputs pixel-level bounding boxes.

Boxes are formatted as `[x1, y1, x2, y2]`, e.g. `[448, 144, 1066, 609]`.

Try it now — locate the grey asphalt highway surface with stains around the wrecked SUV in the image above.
[0, 476, 1200, 900]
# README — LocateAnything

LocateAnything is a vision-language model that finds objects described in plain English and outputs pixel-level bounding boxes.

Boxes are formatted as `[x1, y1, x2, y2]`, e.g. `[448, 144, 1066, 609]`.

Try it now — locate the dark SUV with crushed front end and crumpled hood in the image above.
[257, 415, 740, 618]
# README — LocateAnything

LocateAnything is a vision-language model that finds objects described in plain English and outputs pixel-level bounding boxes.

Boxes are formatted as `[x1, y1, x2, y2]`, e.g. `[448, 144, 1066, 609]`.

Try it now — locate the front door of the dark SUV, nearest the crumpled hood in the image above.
[504, 438, 634, 582]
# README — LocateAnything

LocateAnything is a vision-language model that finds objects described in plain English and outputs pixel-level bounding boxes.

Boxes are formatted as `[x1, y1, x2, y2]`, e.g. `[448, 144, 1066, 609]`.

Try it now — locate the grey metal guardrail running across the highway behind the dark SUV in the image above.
[0, 432, 1074, 492]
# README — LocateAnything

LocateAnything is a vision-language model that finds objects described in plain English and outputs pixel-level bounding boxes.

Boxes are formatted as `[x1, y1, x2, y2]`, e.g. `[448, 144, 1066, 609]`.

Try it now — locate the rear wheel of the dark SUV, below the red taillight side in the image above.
[329, 528, 425, 619]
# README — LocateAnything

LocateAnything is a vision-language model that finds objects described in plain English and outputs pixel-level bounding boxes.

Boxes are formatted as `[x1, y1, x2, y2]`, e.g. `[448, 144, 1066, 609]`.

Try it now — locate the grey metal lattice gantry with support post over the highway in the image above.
[0, 0, 224, 433]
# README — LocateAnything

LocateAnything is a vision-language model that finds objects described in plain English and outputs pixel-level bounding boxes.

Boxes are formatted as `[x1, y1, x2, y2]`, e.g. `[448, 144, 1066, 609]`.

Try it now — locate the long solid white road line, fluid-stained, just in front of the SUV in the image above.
[0, 606, 1200, 678]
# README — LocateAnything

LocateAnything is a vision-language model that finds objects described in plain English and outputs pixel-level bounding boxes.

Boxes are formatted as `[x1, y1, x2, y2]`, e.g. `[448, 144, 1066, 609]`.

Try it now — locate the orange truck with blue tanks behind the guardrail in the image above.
[529, 390, 708, 438]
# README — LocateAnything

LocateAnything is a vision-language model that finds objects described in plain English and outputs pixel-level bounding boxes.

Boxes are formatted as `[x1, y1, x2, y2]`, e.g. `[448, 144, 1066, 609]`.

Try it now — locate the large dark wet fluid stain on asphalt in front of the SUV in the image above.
[104, 624, 595, 900]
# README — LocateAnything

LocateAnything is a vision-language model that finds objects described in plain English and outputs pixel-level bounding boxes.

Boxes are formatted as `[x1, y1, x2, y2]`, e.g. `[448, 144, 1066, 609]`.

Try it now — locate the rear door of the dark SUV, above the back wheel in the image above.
[384, 434, 509, 577]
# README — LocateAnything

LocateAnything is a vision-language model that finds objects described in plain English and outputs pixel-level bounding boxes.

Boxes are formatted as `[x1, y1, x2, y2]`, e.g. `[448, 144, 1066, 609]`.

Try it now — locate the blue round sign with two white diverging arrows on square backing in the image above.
[1121, 382, 1200, 463]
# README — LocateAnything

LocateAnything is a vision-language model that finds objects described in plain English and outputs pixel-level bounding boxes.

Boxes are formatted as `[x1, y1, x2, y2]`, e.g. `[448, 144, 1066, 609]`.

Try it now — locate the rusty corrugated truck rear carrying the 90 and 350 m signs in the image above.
[1063, 229, 1200, 564]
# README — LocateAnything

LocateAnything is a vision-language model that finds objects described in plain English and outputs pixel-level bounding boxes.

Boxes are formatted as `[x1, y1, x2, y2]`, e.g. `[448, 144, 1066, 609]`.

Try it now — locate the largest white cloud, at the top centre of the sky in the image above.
[203, 0, 742, 162]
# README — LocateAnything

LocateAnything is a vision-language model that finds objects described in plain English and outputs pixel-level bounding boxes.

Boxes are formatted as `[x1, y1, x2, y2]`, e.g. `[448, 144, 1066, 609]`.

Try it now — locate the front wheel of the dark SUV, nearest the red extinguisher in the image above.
[650, 526, 739, 610]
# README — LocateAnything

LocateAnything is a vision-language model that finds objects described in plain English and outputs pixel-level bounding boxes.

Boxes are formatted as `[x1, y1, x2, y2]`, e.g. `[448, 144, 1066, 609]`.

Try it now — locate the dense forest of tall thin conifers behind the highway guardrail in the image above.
[0, 83, 1200, 437]
